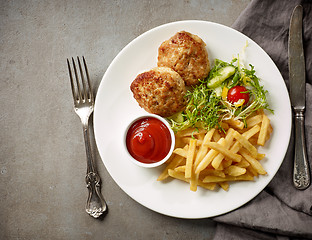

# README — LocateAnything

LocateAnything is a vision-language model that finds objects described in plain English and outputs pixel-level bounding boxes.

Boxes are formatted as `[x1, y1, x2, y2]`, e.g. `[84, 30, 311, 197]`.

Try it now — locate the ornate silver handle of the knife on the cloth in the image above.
[293, 109, 311, 190]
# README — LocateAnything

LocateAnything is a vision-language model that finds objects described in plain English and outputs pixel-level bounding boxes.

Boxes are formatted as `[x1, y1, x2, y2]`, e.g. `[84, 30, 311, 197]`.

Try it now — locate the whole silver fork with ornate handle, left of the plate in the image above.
[67, 57, 107, 218]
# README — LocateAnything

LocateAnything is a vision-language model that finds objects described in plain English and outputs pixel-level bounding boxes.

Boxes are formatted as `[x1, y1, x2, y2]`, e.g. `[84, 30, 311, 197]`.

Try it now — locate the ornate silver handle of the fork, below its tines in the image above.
[83, 124, 107, 218]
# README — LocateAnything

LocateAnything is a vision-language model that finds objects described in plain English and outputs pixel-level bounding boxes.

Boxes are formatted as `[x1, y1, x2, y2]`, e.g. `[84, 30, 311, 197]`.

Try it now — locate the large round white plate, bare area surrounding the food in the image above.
[94, 21, 291, 219]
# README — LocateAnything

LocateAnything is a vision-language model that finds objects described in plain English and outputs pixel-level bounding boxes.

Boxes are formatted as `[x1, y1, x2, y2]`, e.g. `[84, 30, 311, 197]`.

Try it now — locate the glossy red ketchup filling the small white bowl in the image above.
[126, 117, 171, 163]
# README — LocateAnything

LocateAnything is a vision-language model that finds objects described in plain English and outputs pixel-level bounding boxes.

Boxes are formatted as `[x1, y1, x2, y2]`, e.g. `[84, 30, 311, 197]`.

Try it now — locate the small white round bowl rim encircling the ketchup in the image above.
[123, 114, 175, 168]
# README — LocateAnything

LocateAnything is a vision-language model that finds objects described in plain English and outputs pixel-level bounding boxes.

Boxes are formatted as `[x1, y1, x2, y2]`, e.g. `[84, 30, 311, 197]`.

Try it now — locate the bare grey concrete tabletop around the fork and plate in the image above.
[0, 0, 250, 240]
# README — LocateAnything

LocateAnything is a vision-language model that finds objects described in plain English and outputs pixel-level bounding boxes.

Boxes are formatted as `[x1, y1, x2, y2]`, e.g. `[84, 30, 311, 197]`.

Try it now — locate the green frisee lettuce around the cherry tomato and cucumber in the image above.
[168, 56, 273, 132]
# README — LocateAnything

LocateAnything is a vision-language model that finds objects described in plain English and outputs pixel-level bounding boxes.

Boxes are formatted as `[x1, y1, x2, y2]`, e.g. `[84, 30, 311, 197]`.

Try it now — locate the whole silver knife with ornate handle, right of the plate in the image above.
[288, 5, 311, 190]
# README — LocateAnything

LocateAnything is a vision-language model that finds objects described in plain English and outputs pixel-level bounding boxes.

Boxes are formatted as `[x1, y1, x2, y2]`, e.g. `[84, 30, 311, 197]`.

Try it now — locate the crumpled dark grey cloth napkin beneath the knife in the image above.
[213, 0, 312, 240]
